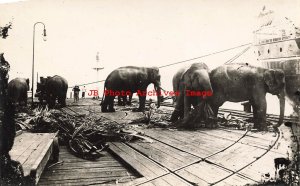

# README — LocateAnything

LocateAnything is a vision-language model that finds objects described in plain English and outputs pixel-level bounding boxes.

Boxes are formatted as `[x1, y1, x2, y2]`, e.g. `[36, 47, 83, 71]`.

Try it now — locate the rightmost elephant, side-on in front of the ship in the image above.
[208, 63, 285, 130]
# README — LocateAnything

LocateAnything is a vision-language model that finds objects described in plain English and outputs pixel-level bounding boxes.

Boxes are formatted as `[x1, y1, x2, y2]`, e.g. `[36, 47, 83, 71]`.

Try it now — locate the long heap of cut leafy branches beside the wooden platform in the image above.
[16, 107, 152, 159]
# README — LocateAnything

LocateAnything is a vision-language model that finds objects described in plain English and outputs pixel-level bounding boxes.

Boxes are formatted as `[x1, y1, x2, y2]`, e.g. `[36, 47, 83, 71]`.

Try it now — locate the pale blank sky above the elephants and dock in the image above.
[0, 0, 300, 115]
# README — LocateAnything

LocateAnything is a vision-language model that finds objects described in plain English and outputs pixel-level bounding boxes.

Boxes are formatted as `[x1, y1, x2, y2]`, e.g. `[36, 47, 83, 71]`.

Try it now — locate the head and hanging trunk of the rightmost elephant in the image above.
[263, 69, 285, 126]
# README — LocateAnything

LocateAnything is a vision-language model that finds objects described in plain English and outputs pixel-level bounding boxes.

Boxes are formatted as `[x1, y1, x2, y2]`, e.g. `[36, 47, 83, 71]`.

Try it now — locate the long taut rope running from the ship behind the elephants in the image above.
[69, 43, 252, 88]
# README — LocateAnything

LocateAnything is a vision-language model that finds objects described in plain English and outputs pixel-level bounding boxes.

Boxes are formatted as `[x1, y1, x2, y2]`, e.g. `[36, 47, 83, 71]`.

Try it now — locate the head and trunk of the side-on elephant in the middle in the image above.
[148, 67, 162, 107]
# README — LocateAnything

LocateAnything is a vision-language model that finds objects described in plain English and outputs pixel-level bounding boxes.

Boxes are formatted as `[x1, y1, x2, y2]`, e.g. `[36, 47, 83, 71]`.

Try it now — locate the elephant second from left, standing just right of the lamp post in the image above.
[37, 75, 68, 108]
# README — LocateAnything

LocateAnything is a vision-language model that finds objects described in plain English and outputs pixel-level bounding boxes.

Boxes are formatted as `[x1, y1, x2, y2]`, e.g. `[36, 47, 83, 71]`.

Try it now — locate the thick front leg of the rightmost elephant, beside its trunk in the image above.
[252, 96, 267, 130]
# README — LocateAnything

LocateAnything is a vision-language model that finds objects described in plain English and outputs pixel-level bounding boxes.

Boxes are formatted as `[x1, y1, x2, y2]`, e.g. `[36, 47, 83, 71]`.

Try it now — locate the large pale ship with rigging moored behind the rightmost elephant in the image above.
[253, 7, 300, 115]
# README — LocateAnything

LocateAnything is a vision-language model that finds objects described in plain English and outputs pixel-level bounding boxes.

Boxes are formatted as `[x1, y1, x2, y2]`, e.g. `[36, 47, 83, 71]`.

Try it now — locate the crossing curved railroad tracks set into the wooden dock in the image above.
[58, 103, 295, 185]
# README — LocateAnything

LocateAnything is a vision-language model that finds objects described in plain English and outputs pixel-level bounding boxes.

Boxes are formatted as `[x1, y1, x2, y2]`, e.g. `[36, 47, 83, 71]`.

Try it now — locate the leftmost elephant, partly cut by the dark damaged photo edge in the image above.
[8, 78, 29, 106]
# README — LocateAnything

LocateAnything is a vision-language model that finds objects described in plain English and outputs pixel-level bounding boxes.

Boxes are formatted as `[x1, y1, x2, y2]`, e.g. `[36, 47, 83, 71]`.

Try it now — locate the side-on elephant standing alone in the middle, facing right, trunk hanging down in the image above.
[101, 66, 161, 112]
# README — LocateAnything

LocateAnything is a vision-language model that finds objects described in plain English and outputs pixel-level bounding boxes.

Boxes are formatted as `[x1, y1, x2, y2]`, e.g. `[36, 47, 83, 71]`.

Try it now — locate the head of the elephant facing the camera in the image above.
[181, 63, 212, 99]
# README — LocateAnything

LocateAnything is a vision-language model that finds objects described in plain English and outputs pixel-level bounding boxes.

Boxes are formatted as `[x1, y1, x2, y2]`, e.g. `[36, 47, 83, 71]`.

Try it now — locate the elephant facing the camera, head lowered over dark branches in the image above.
[170, 63, 213, 122]
